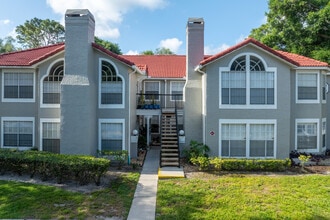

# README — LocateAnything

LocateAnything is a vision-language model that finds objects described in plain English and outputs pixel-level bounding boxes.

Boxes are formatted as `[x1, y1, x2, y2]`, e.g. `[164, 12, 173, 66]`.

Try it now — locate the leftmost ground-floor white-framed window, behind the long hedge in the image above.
[1, 117, 34, 149]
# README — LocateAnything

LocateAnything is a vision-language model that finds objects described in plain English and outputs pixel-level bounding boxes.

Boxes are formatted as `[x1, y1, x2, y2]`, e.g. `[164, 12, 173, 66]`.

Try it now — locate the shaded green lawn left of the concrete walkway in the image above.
[0, 172, 139, 219]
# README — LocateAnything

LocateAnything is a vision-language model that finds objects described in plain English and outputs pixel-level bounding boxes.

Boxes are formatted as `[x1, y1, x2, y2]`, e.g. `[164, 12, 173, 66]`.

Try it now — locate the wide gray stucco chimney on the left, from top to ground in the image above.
[61, 10, 97, 155]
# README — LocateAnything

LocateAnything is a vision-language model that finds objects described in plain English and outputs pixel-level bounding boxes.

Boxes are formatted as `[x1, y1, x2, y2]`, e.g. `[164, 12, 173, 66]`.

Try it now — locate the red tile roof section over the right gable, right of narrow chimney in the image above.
[200, 38, 329, 67]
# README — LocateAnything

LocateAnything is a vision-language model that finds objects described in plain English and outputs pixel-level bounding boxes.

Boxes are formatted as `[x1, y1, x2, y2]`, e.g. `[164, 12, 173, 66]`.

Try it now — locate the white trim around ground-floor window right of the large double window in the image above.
[294, 118, 320, 153]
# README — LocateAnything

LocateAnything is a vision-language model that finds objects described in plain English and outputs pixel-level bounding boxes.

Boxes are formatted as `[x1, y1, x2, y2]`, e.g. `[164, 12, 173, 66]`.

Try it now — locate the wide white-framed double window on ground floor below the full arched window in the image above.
[219, 119, 276, 158]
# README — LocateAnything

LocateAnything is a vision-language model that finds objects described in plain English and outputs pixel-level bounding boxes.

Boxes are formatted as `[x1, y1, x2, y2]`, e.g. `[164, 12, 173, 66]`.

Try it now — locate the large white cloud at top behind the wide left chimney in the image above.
[47, 0, 166, 38]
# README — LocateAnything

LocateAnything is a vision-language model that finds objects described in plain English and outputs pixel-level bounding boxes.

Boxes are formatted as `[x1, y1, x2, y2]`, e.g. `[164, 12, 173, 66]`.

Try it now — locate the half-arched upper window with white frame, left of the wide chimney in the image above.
[40, 60, 64, 107]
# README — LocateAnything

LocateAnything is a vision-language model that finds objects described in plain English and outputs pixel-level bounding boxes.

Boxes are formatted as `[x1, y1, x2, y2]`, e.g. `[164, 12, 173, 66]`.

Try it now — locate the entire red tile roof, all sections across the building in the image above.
[0, 38, 329, 75]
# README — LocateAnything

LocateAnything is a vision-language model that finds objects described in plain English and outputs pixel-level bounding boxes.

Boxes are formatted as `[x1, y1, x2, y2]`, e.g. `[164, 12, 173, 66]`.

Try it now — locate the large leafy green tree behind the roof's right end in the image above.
[250, 0, 330, 63]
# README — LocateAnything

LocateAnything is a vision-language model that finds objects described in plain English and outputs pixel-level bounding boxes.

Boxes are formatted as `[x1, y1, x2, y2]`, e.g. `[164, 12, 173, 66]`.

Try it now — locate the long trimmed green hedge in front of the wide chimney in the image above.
[0, 149, 110, 185]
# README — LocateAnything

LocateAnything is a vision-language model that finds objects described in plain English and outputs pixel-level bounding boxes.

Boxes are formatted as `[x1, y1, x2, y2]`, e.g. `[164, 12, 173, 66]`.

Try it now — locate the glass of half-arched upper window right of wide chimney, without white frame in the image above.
[101, 61, 123, 105]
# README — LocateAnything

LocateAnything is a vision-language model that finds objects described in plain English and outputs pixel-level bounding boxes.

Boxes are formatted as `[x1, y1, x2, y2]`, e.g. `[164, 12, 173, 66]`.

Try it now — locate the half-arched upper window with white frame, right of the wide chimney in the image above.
[99, 60, 125, 108]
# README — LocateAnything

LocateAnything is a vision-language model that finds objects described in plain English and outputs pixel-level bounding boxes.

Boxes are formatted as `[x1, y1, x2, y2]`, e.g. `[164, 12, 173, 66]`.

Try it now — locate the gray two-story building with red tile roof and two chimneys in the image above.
[0, 10, 330, 166]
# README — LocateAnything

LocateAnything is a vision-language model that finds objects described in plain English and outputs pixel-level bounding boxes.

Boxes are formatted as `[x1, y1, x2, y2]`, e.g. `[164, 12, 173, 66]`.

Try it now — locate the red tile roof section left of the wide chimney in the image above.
[0, 43, 64, 66]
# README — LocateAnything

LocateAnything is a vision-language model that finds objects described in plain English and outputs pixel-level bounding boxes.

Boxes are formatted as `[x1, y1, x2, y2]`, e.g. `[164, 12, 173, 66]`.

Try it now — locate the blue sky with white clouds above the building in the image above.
[0, 0, 268, 54]
